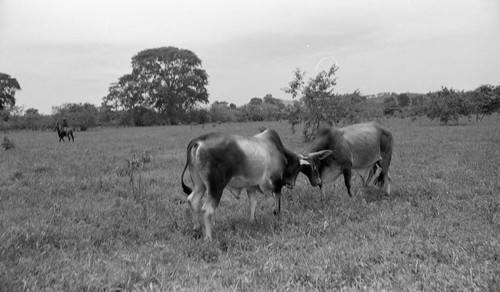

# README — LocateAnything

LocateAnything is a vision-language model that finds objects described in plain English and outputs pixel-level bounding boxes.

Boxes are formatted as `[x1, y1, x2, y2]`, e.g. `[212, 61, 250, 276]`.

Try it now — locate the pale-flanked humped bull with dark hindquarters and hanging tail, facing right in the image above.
[181, 129, 328, 240]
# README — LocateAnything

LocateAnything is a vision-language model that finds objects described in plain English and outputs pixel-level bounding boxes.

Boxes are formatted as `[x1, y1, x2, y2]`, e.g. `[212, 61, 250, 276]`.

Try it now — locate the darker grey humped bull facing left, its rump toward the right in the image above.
[301, 122, 393, 196]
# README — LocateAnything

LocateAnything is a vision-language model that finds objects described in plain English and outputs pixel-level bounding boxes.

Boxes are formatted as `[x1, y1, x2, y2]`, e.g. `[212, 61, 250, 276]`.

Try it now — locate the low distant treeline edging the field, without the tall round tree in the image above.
[0, 85, 500, 131]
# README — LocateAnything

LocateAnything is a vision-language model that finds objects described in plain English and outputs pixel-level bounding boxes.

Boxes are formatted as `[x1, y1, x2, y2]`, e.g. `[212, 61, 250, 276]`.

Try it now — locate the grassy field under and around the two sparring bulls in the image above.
[0, 116, 500, 291]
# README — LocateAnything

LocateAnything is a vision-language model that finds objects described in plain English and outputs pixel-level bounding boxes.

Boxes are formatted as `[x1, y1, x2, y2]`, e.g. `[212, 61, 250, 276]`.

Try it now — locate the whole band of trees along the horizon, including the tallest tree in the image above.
[0, 46, 500, 132]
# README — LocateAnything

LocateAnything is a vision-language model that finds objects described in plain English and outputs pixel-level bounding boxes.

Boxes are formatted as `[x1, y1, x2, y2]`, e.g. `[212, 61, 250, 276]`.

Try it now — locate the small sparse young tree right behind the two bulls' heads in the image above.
[283, 64, 340, 141]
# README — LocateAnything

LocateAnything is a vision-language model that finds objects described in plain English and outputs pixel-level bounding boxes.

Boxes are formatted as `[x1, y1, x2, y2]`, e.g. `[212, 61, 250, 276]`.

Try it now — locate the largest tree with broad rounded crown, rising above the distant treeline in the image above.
[103, 47, 208, 123]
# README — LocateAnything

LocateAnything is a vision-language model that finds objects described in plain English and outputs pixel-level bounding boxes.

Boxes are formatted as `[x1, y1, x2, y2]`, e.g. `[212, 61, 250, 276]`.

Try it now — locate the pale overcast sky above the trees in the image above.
[0, 0, 500, 114]
